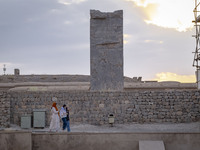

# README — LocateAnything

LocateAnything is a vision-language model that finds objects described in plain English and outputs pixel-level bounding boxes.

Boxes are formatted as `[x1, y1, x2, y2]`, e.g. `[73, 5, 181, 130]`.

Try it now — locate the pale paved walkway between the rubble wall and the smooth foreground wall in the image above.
[0, 121, 200, 133]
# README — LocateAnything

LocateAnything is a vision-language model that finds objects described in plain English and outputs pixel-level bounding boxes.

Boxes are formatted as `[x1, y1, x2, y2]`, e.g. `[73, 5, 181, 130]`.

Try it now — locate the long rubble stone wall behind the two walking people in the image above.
[8, 90, 200, 126]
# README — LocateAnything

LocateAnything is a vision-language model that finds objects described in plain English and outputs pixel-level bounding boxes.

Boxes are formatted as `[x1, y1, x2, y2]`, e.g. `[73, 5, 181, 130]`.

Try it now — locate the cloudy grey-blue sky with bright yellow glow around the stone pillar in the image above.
[0, 0, 196, 82]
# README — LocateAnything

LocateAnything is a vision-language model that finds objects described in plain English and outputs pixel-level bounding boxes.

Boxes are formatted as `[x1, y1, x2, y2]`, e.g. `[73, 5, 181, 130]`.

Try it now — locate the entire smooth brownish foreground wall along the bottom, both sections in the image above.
[0, 131, 200, 150]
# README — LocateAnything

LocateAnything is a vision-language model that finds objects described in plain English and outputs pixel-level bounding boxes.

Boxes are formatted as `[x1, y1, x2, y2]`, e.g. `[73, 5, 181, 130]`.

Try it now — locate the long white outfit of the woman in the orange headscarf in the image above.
[49, 107, 60, 131]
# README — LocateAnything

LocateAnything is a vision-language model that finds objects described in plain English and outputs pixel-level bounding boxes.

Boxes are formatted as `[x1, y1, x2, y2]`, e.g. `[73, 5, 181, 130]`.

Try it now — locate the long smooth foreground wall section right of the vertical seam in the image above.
[32, 132, 200, 150]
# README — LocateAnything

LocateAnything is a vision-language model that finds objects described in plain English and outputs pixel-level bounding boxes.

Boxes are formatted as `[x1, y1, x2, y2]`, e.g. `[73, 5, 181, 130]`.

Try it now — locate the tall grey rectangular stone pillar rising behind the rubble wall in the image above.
[90, 10, 124, 91]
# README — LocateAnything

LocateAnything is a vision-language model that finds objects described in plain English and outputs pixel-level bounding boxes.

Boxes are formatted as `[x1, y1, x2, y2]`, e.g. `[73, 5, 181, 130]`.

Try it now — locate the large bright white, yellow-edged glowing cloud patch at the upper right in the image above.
[125, 0, 194, 31]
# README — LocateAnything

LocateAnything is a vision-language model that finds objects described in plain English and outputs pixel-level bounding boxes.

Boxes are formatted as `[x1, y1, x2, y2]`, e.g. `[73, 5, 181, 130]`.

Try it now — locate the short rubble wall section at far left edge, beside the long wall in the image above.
[0, 91, 10, 128]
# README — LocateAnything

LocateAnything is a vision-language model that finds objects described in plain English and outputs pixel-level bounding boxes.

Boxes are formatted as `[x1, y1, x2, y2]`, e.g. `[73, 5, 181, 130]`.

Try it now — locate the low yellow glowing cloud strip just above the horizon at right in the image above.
[153, 72, 196, 83]
